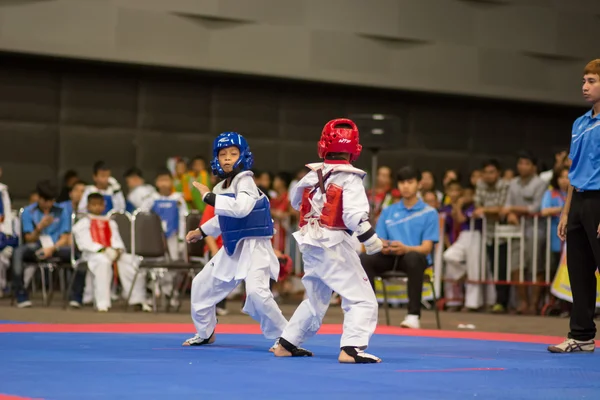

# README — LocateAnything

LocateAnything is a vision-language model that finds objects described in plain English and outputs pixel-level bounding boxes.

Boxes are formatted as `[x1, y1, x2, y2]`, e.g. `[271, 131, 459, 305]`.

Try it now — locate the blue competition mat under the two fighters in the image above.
[0, 333, 600, 400]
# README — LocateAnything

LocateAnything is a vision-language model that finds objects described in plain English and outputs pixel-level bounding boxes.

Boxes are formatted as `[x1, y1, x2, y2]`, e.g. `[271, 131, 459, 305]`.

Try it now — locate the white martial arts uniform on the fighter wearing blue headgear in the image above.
[191, 171, 287, 339]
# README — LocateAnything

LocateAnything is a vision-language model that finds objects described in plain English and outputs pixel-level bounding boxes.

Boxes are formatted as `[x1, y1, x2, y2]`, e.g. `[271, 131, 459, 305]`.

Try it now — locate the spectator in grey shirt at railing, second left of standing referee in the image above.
[500, 152, 548, 314]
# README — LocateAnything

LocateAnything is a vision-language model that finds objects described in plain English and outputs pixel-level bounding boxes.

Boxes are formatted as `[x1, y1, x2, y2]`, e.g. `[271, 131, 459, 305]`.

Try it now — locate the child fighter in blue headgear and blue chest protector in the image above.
[183, 132, 287, 346]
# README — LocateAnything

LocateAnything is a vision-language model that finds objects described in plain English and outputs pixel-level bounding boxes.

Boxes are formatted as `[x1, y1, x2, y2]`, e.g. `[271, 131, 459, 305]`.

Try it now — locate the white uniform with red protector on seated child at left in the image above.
[73, 215, 146, 310]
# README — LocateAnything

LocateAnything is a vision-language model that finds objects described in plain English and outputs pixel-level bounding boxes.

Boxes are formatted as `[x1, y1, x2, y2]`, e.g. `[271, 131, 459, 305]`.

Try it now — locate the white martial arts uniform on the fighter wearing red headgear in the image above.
[281, 163, 378, 349]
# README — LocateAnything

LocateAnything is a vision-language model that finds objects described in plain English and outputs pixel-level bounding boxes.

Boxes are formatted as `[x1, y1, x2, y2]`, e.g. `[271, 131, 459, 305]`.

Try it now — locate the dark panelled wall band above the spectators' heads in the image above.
[0, 54, 585, 202]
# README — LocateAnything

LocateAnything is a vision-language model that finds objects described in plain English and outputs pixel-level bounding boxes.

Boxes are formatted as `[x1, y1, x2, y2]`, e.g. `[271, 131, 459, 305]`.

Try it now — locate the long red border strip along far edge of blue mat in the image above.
[0, 323, 564, 344]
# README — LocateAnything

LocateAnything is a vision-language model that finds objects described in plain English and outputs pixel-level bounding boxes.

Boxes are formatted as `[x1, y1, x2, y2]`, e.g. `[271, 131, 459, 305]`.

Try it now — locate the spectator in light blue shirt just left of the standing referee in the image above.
[541, 167, 569, 276]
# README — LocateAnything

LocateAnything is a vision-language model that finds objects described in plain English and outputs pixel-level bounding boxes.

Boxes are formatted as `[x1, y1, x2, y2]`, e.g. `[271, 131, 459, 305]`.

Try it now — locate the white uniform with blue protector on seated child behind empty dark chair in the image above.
[140, 191, 188, 296]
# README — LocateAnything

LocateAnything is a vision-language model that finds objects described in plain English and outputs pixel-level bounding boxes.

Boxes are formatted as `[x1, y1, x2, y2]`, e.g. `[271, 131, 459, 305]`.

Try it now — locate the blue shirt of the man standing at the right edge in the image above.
[569, 110, 600, 190]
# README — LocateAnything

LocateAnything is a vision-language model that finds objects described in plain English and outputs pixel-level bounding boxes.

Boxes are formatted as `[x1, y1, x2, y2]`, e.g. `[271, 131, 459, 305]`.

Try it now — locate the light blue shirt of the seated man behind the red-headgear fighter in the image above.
[375, 199, 440, 265]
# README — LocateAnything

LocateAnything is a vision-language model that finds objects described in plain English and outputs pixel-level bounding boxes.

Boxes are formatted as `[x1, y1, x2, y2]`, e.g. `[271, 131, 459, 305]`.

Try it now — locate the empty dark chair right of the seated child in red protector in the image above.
[125, 210, 201, 312]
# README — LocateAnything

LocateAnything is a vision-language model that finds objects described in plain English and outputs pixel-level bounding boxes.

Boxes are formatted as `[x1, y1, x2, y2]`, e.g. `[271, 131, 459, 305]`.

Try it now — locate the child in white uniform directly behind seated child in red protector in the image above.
[78, 161, 126, 215]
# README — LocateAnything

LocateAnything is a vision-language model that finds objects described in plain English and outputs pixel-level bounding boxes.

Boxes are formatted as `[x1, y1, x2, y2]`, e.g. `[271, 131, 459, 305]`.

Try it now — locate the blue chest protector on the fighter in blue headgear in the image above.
[219, 193, 273, 255]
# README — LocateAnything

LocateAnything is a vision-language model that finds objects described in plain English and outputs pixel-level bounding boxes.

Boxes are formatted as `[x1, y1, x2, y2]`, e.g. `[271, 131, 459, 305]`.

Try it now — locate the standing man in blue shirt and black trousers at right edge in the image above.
[548, 59, 600, 353]
